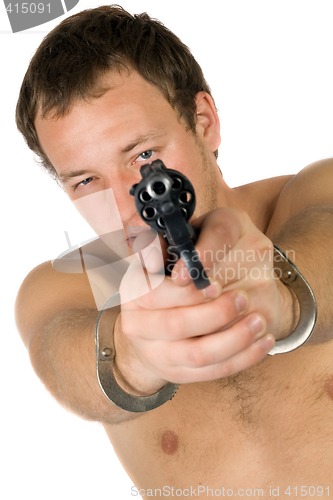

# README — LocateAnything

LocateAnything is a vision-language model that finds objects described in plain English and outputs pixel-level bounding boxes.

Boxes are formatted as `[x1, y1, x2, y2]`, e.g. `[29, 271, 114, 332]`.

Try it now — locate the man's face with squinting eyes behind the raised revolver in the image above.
[36, 71, 217, 240]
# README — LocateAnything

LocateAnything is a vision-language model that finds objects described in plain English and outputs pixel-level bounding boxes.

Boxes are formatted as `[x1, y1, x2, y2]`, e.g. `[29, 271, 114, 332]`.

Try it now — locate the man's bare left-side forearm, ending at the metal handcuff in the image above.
[29, 309, 137, 424]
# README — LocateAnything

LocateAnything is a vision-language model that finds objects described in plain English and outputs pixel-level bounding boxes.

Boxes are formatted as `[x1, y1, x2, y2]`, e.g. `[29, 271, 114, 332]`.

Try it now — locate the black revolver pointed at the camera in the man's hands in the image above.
[130, 160, 210, 289]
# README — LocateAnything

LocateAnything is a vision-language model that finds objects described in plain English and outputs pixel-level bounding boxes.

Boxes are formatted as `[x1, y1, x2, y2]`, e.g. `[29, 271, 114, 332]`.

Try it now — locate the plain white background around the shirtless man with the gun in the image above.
[0, 0, 333, 500]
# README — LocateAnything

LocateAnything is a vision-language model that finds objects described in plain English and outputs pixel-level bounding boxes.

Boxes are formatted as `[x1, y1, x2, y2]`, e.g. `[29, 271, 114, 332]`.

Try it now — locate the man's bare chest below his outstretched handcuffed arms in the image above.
[106, 344, 333, 498]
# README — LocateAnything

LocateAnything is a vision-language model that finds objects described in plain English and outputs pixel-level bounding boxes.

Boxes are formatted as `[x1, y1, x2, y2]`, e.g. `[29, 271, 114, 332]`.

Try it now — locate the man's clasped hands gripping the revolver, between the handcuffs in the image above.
[115, 208, 295, 393]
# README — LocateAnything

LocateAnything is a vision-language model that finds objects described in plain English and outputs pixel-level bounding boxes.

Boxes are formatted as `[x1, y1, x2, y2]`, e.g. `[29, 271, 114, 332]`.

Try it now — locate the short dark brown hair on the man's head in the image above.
[16, 5, 210, 177]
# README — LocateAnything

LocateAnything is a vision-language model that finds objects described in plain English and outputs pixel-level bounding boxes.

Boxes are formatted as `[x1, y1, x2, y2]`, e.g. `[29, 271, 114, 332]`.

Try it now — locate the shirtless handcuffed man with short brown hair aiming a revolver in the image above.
[17, 7, 333, 498]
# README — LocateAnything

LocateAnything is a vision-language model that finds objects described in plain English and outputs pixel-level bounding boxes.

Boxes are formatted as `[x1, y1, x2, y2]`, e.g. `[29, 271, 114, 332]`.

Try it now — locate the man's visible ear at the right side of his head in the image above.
[195, 91, 221, 152]
